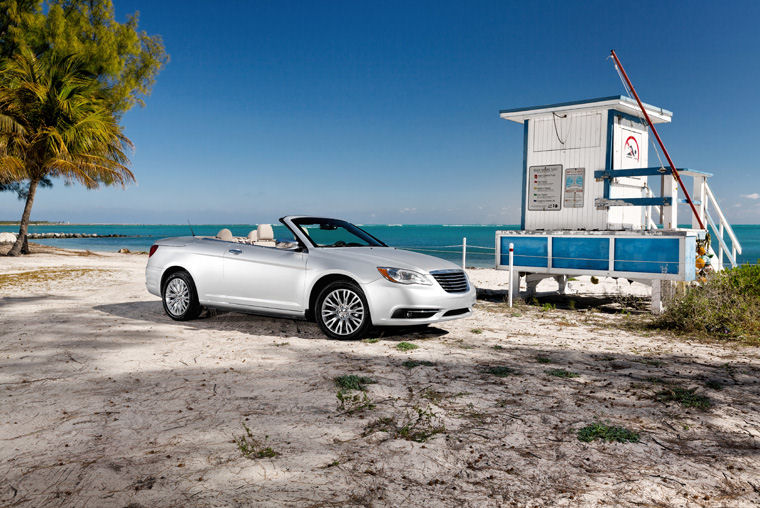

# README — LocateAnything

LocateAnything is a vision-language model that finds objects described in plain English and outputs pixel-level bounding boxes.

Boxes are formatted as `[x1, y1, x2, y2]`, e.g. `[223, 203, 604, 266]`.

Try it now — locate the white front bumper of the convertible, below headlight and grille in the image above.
[363, 279, 476, 326]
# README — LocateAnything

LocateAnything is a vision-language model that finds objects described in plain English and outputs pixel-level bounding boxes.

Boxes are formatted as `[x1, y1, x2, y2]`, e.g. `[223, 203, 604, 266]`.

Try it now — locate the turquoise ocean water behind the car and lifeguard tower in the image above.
[0, 224, 760, 267]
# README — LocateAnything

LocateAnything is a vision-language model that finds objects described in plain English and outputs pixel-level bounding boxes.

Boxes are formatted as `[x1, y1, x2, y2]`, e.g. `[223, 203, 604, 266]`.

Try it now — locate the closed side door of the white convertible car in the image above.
[223, 244, 307, 312]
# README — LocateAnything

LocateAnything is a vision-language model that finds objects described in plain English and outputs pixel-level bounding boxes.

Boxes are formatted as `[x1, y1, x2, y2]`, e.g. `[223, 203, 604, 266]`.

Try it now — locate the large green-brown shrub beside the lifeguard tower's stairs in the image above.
[655, 265, 760, 343]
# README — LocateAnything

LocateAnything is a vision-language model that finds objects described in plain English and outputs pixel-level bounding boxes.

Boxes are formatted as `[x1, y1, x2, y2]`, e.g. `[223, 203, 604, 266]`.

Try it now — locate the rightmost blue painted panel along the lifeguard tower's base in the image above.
[615, 238, 680, 274]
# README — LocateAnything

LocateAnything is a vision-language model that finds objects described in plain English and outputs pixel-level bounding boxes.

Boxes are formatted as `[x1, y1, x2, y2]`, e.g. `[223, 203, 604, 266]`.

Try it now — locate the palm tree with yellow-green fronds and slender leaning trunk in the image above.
[0, 50, 135, 256]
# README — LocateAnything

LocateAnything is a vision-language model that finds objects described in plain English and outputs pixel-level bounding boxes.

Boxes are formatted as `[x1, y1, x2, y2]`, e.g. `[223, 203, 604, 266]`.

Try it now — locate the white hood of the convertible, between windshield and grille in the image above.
[319, 247, 461, 272]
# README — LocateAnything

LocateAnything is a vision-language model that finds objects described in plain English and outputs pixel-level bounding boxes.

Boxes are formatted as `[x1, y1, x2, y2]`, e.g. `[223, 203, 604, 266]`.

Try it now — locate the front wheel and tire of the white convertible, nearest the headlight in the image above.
[314, 281, 372, 340]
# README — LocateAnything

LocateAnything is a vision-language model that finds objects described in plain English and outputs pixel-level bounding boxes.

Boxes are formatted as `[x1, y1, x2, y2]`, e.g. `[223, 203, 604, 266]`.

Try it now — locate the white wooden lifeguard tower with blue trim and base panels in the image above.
[496, 96, 741, 312]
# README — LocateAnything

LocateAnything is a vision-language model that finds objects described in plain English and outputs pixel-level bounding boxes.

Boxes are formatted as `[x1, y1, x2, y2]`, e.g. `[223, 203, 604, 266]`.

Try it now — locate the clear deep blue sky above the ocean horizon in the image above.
[0, 0, 760, 224]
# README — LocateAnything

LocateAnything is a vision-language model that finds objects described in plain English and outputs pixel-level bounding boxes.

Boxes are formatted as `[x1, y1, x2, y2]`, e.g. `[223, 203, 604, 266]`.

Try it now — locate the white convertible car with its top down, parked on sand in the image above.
[145, 216, 475, 339]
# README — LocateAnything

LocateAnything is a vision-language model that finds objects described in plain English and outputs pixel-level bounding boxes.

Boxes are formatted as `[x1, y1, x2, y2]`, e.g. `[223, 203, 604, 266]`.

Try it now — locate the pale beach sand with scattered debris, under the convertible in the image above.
[0, 245, 760, 507]
